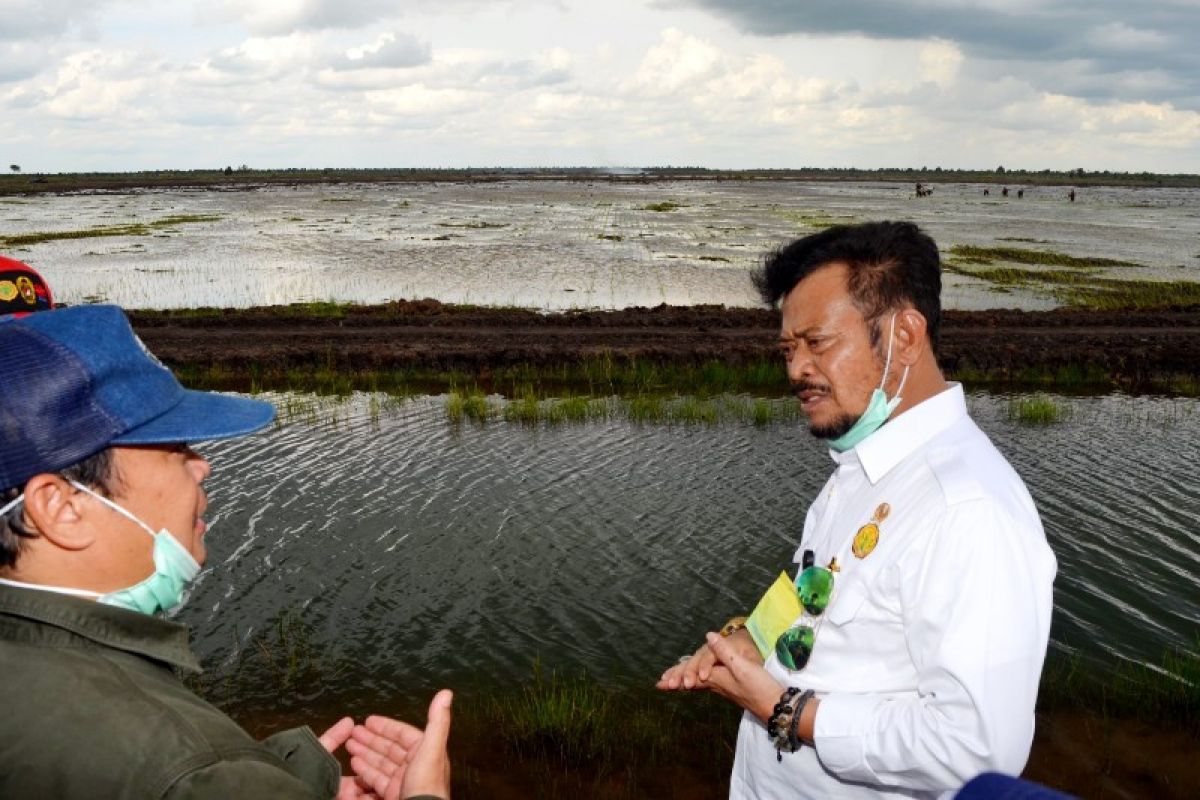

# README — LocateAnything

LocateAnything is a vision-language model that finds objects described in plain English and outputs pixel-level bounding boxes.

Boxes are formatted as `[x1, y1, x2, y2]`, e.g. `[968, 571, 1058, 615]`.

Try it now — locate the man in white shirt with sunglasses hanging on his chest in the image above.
[659, 222, 1056, 799]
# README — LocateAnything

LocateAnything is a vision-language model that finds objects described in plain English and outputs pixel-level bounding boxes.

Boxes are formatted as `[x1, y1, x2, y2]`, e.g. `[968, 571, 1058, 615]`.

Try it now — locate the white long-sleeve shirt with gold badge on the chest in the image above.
[730, 384, 1056, 800]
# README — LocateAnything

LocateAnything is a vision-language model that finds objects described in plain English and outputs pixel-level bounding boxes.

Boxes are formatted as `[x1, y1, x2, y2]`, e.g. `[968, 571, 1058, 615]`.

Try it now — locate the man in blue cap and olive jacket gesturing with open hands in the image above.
[0, 306, 450, 800]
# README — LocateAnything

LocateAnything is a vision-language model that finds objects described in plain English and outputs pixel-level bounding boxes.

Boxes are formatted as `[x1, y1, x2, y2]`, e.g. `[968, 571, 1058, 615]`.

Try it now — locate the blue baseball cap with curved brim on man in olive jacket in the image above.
[0, 306, 275, 489]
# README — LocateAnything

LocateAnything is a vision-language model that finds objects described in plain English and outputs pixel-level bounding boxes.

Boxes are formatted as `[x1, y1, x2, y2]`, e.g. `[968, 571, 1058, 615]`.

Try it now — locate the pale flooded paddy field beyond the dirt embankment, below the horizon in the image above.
[9, 181, 1200, 309]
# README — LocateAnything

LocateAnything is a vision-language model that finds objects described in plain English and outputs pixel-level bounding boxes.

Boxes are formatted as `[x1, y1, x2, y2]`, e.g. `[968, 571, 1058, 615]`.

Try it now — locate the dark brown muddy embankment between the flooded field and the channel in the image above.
[130, 300, 1200, 387]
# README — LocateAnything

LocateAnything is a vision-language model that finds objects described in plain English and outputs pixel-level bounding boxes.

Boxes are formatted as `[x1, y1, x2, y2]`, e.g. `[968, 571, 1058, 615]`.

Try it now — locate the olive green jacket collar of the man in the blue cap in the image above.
[0, 585, 200, 673]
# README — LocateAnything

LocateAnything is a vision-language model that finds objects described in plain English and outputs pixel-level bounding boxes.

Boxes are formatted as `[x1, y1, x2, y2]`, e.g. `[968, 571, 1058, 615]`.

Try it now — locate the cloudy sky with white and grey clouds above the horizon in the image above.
[0, 0, 1200, 173]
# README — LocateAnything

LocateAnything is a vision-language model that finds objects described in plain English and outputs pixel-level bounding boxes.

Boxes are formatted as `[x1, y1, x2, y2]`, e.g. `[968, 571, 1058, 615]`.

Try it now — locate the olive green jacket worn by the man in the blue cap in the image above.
[0, 584, 341, 800]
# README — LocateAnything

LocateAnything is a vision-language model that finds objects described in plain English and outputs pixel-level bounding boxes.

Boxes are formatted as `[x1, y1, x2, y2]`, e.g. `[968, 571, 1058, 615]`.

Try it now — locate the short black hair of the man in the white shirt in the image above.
[752, 222, 942, 353]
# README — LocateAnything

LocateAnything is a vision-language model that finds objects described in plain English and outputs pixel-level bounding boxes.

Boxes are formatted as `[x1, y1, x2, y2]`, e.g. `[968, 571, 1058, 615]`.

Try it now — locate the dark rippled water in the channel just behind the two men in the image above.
[180, 395, 1200, 708]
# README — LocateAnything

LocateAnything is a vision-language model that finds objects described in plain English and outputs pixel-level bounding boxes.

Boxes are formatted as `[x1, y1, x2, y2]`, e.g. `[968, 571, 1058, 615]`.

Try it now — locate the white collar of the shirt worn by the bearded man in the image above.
[829, 384, 967, 486]
